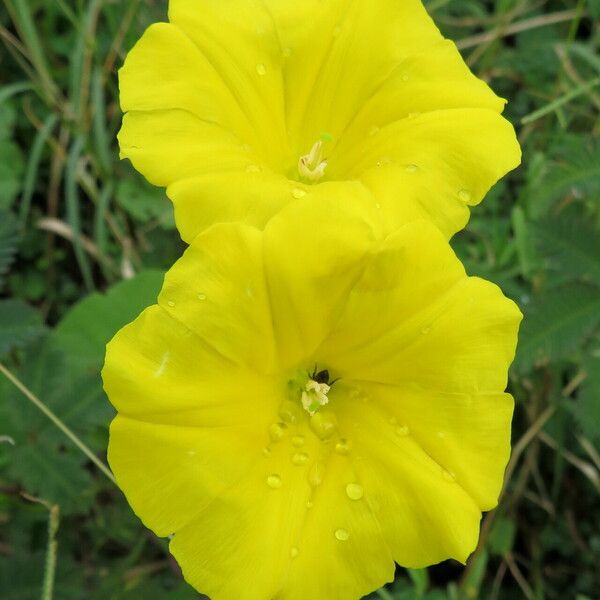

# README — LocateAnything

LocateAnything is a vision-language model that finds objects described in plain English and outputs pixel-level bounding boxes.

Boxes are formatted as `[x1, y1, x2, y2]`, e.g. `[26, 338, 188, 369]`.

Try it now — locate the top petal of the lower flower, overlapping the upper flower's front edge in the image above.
[264, 182, 378, 368]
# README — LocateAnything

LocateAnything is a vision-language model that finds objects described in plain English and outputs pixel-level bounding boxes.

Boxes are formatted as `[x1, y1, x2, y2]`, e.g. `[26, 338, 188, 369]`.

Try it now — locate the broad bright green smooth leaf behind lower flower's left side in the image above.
[52, 271, 163, 374]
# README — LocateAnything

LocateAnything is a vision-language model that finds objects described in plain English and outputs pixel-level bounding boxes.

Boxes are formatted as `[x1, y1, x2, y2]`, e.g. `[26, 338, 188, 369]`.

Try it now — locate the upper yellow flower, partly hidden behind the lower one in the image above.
[119, 0, 520, 242]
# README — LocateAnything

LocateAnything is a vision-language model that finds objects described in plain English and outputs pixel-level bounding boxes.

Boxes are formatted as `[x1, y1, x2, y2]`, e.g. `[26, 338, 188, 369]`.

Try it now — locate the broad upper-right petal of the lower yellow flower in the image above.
[318, 222, 521, 393]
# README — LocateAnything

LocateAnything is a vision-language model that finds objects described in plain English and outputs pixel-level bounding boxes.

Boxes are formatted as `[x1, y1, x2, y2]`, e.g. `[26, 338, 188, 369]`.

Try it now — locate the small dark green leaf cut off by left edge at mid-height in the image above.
[0, 300, 44, 356]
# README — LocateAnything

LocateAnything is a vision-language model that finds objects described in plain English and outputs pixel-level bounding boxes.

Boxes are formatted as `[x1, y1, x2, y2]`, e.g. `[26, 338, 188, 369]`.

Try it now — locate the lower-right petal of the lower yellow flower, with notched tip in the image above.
[338, 398, 481, 568]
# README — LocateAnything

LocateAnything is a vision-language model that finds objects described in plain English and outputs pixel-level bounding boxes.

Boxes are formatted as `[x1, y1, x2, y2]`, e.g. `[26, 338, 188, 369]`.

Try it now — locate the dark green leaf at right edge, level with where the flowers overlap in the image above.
[529, 213, 600, 285]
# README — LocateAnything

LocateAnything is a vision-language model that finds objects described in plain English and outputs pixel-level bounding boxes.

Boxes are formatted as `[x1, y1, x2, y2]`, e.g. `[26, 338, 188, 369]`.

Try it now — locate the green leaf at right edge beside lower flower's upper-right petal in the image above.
[515, 283, 600, 371]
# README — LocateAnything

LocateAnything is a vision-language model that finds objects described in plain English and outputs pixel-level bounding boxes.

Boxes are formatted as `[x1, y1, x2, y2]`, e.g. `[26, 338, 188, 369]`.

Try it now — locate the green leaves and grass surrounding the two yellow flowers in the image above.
[0, 0, 600, 600]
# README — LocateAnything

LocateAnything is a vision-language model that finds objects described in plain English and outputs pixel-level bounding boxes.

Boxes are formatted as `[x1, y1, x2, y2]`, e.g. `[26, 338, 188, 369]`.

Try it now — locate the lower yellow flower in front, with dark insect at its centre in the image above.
[103, 190, 521, 600]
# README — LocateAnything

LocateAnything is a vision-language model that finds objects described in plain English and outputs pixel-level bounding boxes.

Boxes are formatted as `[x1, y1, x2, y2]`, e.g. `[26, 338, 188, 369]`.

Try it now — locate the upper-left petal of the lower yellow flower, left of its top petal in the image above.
[158, 224, 276, 373]
